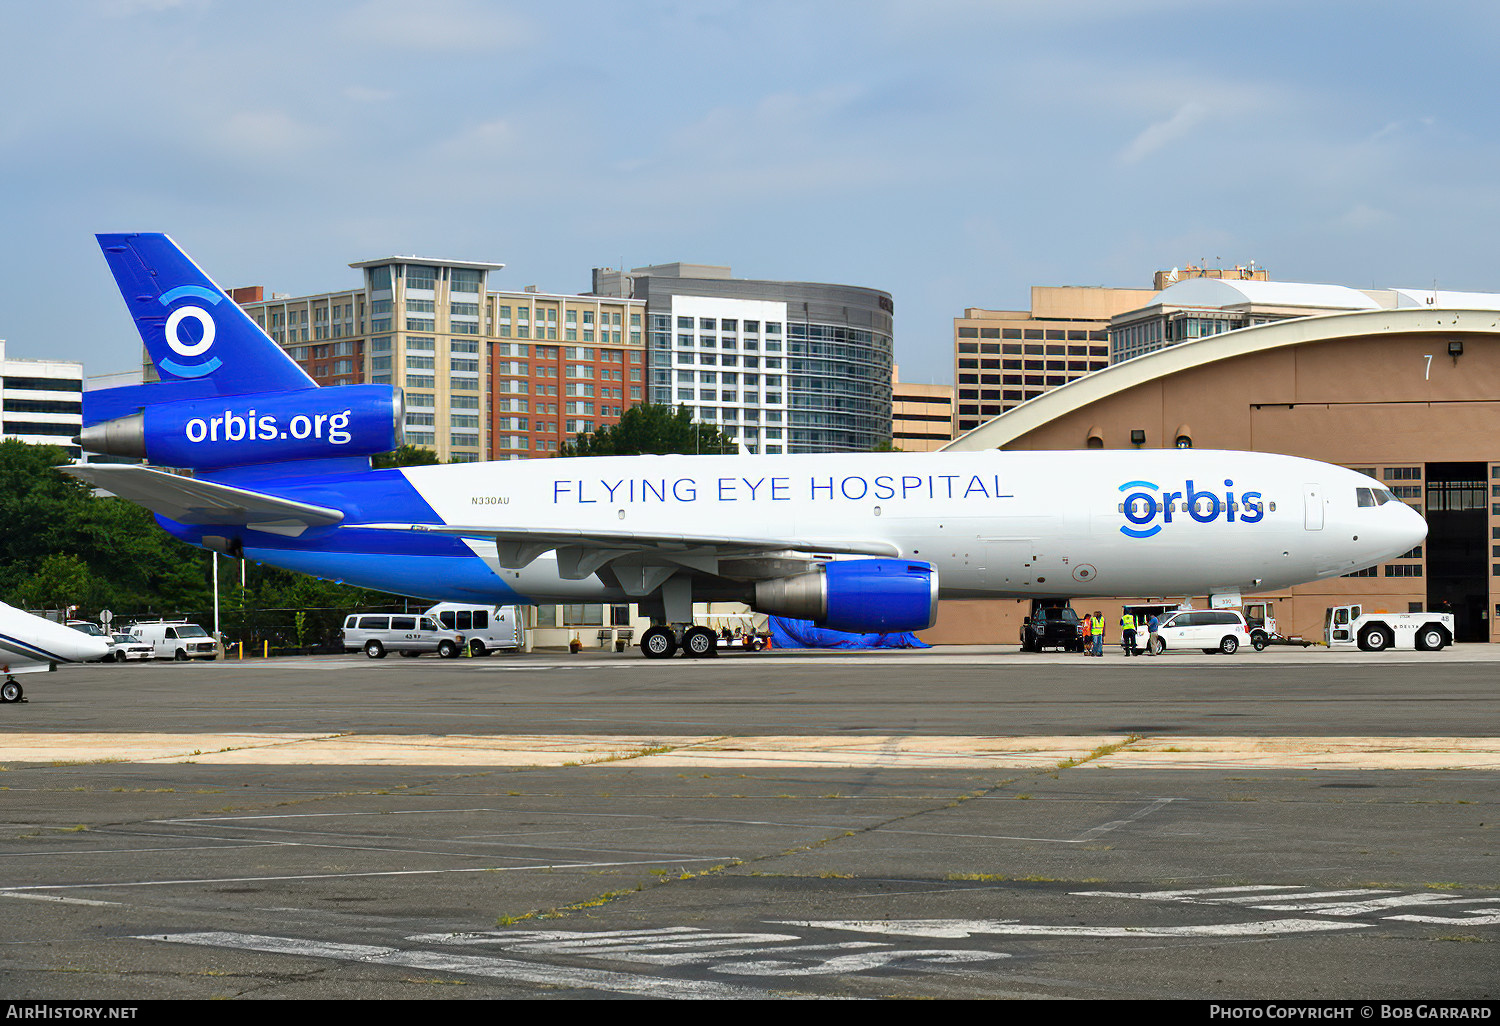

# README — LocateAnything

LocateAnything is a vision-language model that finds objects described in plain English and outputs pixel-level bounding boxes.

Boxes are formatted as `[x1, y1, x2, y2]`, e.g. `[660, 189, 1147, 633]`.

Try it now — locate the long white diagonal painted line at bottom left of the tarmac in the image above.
[137, 932, 776, 999]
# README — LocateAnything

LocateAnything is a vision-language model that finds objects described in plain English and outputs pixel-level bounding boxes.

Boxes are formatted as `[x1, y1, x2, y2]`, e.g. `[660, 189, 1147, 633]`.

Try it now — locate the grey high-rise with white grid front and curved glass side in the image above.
[593, 264, 894, 453]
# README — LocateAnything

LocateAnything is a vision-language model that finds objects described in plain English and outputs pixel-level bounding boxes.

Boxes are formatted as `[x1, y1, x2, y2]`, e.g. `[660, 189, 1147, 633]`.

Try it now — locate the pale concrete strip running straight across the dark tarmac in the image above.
[14, 732, 1500, 773]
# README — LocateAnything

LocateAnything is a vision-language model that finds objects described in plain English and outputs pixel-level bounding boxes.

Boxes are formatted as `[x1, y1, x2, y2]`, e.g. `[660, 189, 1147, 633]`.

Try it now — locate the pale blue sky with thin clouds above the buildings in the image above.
[0, 0, 1500, 383]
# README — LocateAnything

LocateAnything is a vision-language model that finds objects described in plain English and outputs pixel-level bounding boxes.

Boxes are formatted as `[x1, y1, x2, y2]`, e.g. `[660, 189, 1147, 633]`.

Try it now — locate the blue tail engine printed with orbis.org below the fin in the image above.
[80, 386, 405, 470]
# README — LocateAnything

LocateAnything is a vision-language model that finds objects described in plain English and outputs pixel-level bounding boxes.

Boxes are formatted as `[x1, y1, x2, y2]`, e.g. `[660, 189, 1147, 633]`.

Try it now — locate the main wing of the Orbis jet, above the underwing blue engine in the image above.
[359, 524, 902, 591]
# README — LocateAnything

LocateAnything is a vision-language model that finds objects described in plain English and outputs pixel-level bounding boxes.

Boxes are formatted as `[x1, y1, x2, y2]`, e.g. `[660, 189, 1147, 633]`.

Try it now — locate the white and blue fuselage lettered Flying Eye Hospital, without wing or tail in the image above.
[171, 450, 1427, 603]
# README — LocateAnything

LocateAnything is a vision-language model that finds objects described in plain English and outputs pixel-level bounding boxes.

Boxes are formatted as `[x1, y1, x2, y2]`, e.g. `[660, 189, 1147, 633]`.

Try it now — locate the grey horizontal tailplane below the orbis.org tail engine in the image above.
[59, 464, 344, 537]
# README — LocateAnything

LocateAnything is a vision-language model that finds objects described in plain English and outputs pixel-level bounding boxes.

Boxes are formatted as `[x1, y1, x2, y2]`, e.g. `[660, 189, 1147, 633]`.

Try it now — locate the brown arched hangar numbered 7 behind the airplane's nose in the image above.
[921, 294, 1500, 644]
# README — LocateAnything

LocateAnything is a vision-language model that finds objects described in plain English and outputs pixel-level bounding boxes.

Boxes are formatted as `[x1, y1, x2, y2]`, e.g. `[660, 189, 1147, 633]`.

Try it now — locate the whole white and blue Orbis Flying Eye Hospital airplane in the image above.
[68, 234, 1427, 657]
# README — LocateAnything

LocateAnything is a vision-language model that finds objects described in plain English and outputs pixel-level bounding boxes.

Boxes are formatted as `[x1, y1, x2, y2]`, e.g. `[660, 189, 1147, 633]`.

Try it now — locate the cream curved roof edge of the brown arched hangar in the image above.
[944, 304, 1500, 452]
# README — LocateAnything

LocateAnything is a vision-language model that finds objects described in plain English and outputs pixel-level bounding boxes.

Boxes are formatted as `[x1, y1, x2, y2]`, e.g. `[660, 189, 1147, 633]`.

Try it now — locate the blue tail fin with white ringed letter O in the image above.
[98, 233, 318, 396]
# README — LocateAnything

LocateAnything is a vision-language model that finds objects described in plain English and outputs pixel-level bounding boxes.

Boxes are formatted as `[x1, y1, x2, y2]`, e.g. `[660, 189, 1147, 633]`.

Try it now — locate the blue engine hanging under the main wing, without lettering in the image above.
[755, 560, 938, 635]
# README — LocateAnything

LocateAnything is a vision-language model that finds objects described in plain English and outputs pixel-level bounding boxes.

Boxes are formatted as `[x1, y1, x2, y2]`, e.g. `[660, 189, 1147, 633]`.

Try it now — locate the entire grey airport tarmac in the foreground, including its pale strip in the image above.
[0, 647, 1500, 996]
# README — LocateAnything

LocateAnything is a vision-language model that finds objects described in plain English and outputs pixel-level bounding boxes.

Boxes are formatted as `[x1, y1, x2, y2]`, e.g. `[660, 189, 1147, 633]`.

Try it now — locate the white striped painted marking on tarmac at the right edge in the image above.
[1074, 884, 1500, 926]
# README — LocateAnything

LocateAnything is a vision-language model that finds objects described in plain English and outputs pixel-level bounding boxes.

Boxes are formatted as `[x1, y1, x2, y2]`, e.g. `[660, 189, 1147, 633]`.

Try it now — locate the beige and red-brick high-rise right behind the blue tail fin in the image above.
[231, 257, 645, 462]
